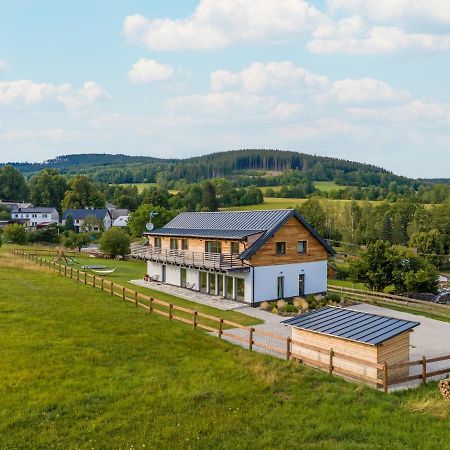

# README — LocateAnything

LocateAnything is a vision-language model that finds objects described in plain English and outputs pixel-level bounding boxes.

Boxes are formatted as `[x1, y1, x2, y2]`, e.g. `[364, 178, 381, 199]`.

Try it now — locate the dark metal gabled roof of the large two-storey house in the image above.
[147, 209, 334, 259]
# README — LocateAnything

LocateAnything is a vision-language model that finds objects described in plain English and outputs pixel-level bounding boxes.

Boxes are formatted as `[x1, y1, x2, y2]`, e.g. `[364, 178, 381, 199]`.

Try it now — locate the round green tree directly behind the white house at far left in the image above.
[29, 169, 68, 208]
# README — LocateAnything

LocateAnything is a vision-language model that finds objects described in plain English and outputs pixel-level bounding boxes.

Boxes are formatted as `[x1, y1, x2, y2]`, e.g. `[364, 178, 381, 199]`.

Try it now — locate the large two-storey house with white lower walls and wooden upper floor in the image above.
[140, 209, 333, 305]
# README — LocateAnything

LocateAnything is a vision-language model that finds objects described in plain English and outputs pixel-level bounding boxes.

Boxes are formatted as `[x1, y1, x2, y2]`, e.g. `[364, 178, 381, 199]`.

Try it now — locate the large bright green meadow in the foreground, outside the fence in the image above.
[0, 252, 450, 449]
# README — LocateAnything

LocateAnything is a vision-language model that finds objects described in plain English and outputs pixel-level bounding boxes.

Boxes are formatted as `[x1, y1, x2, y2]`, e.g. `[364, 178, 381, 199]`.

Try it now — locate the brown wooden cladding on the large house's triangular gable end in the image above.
[250, 217, 328, 266]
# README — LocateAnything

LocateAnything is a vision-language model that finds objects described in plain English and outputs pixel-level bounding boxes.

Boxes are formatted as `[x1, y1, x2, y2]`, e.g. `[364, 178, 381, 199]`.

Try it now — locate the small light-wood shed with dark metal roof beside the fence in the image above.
[283, 307, 420, 380]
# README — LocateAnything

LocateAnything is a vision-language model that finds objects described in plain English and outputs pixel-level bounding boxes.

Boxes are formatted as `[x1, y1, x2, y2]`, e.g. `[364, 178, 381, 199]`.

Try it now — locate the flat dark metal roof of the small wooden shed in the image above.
[282, 306, 420, 345]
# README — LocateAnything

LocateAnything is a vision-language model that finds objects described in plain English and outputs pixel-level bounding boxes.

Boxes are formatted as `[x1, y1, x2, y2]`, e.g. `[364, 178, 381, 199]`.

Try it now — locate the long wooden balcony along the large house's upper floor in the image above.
[131, 244, 249, 272]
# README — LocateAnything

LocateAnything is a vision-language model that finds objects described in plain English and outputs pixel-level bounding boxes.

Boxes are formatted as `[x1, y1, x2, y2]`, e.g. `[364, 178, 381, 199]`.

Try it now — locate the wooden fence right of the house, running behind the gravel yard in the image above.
[327, 284, 450, 319]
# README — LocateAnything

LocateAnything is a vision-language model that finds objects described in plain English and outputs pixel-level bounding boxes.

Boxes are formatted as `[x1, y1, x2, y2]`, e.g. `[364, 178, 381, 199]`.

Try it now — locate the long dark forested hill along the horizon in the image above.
[3, 149, 442, 188]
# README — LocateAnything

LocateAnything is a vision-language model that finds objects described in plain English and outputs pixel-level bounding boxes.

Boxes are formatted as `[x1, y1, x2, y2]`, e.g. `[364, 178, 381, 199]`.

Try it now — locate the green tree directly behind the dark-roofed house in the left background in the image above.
[62, 175, 105, 209]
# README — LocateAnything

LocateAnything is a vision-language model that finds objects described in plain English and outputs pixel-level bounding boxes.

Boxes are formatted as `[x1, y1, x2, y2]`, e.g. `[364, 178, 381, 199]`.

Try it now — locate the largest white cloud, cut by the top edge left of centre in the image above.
[123, 0, 326, 50]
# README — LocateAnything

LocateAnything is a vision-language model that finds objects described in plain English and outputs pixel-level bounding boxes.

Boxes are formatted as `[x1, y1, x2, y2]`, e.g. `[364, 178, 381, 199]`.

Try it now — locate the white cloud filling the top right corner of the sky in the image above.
[327, 0, 450, 23]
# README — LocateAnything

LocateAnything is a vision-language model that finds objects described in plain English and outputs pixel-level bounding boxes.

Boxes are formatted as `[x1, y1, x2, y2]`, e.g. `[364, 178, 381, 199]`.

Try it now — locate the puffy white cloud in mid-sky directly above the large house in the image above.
[211, 61, 329, 92]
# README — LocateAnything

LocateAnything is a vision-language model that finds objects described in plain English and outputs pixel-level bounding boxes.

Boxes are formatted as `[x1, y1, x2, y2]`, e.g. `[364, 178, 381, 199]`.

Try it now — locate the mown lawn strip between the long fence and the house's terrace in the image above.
[37, 250, 262, 325]
